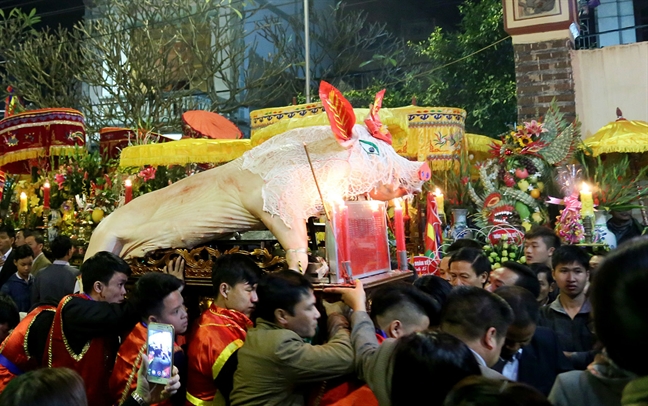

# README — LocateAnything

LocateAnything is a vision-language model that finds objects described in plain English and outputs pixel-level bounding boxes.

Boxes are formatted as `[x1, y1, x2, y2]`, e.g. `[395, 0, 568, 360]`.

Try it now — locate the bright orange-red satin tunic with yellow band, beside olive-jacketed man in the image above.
[185, 304, 252, 405]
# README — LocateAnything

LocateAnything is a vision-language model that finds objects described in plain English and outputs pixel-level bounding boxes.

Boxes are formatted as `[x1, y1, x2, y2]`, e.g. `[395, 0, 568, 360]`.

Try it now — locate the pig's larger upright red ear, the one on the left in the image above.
[319, 81, 355, 145]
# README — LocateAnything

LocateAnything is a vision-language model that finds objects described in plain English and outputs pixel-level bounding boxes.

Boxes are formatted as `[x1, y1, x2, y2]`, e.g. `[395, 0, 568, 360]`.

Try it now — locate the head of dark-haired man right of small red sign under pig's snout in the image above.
[450, 248, 492, 288]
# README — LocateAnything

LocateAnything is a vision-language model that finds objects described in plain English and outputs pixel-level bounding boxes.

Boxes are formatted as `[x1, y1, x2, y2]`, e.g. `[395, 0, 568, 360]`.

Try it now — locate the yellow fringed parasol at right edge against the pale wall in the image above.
[584, 109, 648, 157]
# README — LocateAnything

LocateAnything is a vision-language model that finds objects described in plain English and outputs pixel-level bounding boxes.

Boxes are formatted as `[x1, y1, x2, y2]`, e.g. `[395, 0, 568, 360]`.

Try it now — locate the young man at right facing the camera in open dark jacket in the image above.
[538, 245, 596, 369]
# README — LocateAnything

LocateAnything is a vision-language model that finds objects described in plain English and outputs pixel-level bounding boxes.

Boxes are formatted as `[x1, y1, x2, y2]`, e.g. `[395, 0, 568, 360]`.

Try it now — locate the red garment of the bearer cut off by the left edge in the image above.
[0, 305, 56, 393]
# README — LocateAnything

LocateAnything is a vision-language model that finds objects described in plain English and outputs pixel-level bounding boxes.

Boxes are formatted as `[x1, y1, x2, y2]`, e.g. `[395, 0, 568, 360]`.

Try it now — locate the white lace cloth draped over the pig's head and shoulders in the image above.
[242, 125, 422, 228]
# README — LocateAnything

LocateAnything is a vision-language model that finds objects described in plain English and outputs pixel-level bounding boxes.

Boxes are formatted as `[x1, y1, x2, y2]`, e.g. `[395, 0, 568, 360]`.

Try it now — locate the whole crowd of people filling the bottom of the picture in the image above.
[0, 222, 648, 406]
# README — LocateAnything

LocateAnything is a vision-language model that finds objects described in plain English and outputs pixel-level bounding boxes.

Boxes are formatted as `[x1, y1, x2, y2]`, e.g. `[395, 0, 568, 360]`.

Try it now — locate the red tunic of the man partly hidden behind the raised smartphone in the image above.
[108, 323, 182, 405]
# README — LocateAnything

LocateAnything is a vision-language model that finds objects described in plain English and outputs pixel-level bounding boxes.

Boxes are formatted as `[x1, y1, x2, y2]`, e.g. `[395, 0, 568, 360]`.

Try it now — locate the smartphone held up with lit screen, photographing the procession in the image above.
[146, 323, 174, 384]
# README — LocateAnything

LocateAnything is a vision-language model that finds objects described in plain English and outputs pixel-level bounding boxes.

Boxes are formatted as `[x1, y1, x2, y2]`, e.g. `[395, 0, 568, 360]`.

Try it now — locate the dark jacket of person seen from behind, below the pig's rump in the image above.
[32, 264, 79, 303]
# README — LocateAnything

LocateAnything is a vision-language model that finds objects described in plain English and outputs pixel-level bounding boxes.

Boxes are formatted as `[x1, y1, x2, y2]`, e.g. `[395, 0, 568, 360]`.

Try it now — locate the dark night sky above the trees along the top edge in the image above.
[0, 0, 463, 40]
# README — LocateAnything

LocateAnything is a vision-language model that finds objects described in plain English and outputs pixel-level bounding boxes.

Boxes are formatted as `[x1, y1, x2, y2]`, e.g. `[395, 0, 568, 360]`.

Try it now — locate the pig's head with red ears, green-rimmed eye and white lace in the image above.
[242, 82, 430, 227]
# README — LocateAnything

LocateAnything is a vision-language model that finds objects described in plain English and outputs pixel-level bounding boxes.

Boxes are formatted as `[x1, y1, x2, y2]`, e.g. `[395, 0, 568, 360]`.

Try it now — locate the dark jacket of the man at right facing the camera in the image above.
[538, 295, 596, 370]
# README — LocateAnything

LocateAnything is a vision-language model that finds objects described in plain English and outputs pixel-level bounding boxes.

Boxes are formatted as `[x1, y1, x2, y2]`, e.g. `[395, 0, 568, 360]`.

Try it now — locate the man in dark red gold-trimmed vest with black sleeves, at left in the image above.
[45, 251, 138, 406]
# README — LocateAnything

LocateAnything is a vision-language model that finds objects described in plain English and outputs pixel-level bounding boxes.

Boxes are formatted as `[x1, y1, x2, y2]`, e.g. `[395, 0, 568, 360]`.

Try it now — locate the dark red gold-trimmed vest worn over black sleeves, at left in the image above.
[45, 294, 116, 406]
